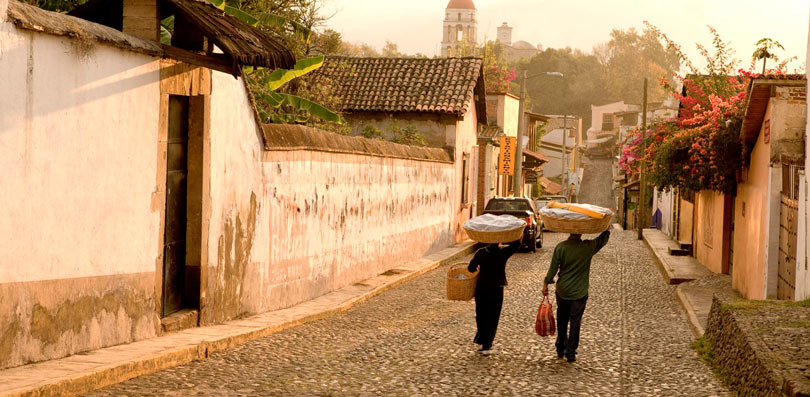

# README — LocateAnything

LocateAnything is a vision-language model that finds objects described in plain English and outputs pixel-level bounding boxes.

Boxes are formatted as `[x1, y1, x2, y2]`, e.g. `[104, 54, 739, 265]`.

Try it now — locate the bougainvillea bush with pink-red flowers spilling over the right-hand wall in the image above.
[619, 27, 751, 193]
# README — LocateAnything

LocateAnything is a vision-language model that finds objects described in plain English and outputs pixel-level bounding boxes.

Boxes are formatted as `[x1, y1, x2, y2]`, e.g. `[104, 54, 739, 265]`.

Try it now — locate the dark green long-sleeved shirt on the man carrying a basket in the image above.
[545, 230, 610, 300]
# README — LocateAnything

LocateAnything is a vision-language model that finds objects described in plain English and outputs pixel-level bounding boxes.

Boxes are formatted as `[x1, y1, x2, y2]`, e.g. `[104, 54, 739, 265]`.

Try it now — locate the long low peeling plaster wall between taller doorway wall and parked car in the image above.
[256, 151, 454, 310]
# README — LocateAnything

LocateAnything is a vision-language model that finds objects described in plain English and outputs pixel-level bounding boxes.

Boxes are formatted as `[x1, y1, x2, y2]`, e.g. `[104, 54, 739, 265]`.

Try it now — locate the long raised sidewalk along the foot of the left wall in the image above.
[0, 240, 474, 396]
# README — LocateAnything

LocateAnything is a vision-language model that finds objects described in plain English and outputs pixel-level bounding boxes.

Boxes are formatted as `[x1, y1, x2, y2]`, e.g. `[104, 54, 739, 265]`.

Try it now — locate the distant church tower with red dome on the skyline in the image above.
[442, 0, 478, 57]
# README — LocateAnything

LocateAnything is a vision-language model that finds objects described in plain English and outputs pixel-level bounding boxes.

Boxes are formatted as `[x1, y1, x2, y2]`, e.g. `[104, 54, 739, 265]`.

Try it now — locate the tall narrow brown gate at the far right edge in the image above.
[776, 156, 804, 301]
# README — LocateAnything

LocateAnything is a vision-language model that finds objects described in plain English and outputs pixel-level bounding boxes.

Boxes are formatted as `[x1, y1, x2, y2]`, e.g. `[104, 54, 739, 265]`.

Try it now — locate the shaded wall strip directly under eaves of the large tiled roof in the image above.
[345, 113, 458, 148]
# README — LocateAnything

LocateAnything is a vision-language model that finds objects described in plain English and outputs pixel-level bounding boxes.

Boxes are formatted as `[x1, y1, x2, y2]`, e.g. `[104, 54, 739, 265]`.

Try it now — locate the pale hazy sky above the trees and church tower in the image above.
[325, 0, 810, 70]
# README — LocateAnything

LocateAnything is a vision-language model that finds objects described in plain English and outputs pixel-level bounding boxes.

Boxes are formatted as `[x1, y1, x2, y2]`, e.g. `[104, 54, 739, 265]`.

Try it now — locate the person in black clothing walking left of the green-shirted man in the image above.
[467, 240, 520, 355]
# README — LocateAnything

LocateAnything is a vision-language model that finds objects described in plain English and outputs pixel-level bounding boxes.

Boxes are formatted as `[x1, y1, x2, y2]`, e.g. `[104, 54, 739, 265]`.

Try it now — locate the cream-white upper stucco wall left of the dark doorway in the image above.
[0, 24, 159, 283]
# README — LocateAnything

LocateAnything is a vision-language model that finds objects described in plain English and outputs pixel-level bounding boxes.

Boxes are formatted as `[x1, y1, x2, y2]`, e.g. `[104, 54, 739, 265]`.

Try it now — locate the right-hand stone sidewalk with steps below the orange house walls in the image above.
[643, 229, 737, 337]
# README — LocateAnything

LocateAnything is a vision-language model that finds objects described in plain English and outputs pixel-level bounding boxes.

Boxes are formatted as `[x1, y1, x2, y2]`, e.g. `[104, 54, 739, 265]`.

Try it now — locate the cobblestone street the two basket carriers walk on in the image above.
[87, 232, 728, 396]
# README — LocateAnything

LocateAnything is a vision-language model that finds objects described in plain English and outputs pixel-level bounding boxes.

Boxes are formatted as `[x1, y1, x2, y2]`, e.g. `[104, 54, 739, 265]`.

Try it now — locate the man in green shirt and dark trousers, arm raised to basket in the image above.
[543, 230, 610, 363]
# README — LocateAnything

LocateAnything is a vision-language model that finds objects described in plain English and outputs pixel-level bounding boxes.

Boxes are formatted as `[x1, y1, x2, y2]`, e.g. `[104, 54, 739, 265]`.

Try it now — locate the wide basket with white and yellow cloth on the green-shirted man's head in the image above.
[540, 201, 613, 234]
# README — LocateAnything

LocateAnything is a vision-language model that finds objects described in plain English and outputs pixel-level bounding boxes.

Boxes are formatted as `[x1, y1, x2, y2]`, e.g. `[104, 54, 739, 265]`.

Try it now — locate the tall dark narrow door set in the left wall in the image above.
[162, 95, 189, 317]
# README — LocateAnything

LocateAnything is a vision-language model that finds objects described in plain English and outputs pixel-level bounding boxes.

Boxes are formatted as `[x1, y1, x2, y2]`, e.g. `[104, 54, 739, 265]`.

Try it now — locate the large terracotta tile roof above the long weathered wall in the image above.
[318, 57, 486, 122]
